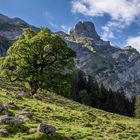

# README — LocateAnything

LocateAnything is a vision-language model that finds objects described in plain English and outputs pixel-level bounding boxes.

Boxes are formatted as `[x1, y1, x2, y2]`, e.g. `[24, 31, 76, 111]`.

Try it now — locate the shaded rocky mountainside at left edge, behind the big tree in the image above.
[0, 14, 38, 56]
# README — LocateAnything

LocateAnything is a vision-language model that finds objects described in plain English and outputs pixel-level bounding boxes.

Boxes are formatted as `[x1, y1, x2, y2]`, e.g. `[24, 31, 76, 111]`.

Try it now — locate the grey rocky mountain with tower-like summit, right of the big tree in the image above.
[59, 22, 140, 98]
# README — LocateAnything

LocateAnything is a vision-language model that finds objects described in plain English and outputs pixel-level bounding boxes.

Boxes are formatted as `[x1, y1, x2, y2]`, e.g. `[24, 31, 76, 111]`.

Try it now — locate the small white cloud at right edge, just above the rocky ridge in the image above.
[126, 36, 140, 52]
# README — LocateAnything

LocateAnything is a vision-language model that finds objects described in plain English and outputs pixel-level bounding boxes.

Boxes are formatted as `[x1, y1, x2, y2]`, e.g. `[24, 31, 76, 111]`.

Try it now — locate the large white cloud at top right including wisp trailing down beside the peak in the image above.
[72, 0, 140, 40]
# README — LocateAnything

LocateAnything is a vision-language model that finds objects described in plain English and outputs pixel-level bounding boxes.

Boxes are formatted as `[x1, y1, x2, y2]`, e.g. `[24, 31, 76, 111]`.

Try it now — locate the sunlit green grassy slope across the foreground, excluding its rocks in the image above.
[0, 81, 140, 140]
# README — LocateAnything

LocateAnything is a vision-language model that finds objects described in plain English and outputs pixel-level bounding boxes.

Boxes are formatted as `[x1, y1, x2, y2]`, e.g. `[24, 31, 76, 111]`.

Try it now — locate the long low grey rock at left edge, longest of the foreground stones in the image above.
[0, 115, 23, 125]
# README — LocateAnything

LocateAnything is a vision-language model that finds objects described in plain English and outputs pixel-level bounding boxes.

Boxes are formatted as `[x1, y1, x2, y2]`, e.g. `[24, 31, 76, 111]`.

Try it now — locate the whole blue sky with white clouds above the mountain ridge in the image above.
[0, 0, 140, 51]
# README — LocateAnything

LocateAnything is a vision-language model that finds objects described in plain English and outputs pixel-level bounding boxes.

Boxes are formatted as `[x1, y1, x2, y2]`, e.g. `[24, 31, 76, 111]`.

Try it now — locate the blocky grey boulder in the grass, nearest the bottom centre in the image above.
[37, 123, 56, 136]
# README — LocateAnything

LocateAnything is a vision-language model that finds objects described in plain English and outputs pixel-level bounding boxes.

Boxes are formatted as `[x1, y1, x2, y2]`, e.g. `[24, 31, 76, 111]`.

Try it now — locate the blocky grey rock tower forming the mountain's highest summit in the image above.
[70, 21, 100, 40]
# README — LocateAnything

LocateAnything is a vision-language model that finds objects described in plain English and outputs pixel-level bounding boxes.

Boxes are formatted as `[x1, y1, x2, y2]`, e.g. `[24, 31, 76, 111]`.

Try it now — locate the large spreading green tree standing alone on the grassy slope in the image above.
[1, 28, 76, 94]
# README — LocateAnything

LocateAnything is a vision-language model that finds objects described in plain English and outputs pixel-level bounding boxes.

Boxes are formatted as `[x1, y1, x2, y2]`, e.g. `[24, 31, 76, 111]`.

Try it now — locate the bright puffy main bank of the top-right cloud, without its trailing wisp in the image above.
[72, 0, 140, 22]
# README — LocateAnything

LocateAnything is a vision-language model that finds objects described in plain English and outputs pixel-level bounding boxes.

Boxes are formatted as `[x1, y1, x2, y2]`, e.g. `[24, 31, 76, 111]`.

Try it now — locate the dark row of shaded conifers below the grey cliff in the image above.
[70, 70, 135, 116]
